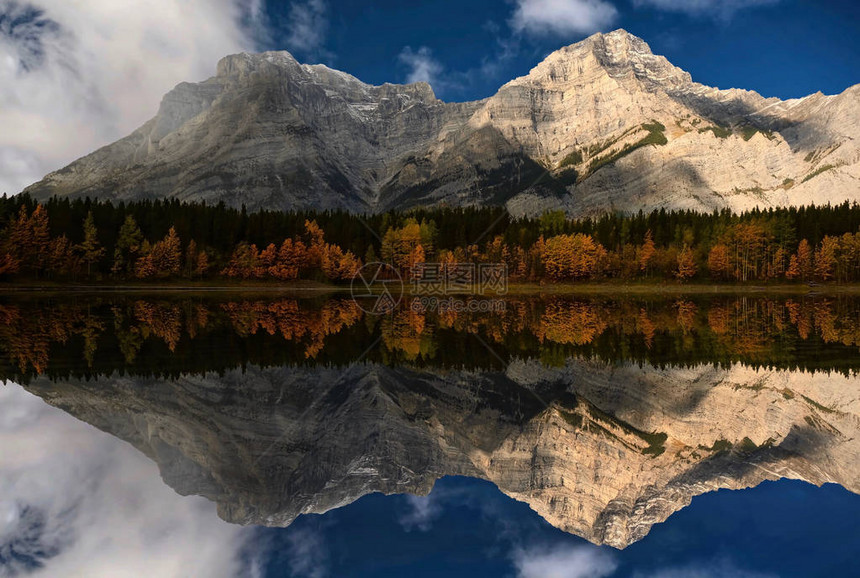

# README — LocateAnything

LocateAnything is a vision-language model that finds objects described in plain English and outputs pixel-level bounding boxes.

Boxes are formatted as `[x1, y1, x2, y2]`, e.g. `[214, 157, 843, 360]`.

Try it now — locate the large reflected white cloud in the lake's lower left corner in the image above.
[0, 384, 259, 578]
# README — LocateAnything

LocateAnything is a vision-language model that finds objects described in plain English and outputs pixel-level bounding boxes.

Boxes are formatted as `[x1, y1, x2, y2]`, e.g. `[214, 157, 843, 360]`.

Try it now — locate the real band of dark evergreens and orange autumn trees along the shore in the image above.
[0, 195, 860, 283]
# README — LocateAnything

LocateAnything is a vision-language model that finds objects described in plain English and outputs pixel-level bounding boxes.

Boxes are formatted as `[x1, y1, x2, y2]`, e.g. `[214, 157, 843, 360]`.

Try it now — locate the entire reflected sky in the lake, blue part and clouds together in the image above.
[0, 383, 860, 578]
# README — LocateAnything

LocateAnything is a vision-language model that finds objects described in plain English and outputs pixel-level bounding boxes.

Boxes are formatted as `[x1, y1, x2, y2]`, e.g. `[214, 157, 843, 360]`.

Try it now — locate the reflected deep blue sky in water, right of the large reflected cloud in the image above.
[256, 478, 860, 578]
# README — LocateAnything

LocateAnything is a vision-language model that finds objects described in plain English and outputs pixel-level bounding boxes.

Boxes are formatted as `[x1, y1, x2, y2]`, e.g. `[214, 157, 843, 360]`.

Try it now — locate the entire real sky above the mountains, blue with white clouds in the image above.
[0, 0, 860, 194]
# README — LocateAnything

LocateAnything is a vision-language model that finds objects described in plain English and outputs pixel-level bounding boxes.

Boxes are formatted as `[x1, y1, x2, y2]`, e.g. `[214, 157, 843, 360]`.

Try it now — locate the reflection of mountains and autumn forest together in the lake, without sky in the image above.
[0, 297, 860, 548]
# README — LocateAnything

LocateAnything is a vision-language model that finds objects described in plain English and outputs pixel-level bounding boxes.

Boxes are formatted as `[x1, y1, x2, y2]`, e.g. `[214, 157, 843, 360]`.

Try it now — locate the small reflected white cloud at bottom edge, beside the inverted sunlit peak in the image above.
[514, 546, 618, 578]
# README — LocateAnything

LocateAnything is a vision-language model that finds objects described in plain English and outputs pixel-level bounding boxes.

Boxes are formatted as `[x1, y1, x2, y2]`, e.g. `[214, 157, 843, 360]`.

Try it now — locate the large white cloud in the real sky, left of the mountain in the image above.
[0, 0, 265, 194]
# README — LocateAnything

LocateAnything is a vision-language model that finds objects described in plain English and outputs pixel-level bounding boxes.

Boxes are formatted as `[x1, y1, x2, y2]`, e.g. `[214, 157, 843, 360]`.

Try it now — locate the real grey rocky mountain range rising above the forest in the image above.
[21, 30, 860, 215]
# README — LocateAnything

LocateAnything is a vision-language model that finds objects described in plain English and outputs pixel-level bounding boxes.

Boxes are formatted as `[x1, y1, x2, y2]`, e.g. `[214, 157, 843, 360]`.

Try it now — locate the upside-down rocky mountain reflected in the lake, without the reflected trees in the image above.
[25, 359, 860, 548]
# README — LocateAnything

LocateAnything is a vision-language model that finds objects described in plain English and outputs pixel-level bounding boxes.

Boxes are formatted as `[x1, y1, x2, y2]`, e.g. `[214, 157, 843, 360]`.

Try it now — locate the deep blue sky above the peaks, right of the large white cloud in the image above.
[261, 0, 860, 100]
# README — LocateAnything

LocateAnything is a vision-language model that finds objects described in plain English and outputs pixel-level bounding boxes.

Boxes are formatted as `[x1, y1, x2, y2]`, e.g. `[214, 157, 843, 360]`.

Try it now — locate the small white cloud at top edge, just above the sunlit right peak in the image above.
[510, 0, 618, 36]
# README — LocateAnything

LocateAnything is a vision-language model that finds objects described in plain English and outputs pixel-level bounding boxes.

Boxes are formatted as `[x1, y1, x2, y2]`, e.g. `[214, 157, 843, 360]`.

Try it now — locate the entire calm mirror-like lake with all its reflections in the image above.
[0, 294, 860, 578]
